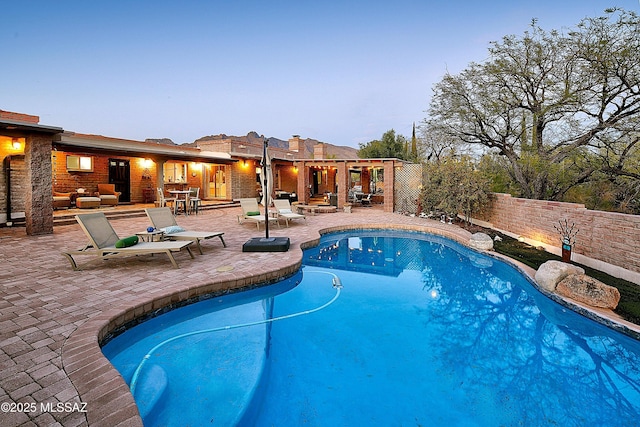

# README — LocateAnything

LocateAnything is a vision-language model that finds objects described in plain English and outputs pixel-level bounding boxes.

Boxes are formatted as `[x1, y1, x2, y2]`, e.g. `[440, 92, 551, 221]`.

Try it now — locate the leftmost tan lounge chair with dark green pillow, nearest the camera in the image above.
[63, 212, 194, 270]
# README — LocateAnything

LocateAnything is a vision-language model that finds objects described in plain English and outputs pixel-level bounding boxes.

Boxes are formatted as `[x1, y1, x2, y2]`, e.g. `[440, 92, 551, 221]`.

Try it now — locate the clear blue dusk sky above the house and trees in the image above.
[0, 0, 640, 148]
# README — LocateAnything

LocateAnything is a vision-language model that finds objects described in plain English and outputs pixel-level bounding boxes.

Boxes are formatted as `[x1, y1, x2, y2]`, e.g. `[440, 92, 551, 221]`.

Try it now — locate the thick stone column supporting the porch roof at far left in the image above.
[24, 134, 53, 235]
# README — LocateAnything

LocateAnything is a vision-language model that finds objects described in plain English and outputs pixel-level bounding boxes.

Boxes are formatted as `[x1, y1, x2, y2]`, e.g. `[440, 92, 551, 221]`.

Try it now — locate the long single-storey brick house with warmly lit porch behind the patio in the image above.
[0, 110, 421, 235]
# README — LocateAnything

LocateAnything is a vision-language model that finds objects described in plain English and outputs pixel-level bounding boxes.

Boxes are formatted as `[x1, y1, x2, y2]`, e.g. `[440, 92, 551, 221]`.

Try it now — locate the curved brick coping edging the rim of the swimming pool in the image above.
[61, 223, 640, 426]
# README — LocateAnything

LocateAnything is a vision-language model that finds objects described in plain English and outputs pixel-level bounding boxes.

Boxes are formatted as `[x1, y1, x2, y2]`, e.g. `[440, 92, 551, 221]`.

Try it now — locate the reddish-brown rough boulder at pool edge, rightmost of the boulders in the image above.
[556, 274, 620, 310]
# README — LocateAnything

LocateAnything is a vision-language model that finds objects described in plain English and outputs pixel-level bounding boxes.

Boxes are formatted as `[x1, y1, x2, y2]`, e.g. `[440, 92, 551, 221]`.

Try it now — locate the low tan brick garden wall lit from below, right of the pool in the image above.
[482, 194, 640, 280]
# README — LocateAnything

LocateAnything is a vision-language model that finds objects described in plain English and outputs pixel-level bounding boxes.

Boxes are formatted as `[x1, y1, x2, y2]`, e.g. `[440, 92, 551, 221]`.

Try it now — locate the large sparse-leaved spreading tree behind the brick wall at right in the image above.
[426, 9, 640, 204]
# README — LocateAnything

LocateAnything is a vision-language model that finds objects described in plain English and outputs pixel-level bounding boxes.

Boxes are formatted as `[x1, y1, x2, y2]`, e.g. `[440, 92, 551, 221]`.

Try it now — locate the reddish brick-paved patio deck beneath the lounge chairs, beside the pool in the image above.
[0, 207, 636, 427]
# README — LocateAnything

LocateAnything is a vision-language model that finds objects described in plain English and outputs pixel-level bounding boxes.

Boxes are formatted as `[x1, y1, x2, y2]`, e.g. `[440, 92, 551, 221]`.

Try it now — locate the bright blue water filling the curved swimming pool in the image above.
[103, 230, 640, 427]
